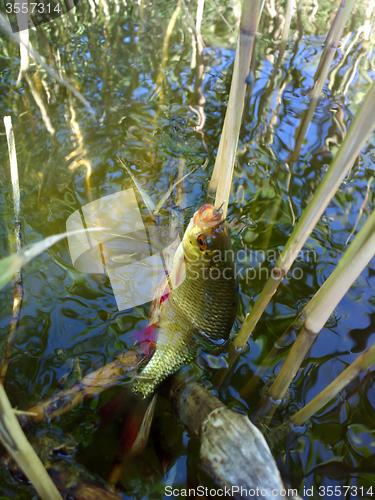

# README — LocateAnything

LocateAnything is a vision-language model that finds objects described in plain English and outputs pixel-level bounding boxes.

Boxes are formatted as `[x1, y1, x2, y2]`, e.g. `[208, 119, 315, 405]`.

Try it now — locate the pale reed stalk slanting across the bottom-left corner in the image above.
[0, 384, 62, 500]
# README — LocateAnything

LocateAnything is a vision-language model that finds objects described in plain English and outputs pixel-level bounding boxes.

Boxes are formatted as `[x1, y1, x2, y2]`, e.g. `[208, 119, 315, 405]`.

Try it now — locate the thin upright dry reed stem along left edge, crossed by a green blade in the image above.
[0, 116, 23, 385]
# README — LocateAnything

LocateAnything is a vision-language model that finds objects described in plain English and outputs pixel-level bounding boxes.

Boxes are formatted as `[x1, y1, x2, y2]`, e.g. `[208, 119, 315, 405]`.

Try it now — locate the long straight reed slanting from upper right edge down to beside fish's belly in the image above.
[234, 83, 375, 349]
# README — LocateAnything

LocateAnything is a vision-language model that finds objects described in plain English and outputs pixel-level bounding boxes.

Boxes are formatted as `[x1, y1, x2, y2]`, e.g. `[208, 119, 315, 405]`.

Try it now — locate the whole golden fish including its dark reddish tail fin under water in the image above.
[101, 204, 238, 457]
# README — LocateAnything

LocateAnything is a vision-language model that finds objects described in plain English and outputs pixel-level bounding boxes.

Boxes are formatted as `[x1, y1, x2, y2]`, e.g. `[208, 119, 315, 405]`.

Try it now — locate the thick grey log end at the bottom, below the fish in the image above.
[171, 383, 300, 499]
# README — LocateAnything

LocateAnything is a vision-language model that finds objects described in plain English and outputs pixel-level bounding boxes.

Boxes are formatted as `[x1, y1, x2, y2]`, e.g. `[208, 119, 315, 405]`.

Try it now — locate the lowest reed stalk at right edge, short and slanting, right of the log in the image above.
[268, 345, 375, 444]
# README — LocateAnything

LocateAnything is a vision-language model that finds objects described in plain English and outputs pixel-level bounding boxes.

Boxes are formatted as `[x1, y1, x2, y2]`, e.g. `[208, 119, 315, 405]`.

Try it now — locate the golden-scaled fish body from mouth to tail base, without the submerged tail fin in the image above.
[132, 205, 238, 398]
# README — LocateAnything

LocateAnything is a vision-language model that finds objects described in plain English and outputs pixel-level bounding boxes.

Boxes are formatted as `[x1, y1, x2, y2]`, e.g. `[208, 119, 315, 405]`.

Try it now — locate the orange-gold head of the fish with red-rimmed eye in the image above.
[182, 204, 231, 265]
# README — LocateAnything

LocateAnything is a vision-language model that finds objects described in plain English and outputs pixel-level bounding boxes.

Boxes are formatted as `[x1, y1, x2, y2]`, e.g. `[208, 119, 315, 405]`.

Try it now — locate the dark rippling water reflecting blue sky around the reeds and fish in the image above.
[0, 0, 375, 499]
